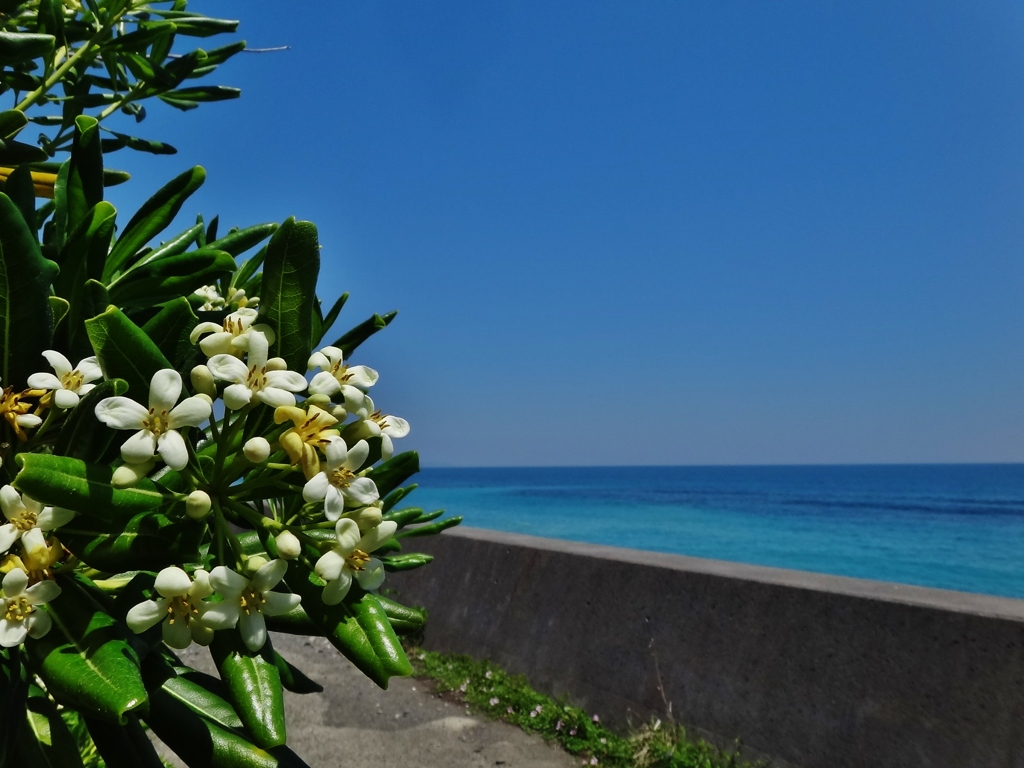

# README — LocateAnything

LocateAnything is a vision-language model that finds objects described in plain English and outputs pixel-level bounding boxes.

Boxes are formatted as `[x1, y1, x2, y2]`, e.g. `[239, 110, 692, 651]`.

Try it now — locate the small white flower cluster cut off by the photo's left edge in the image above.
[0, 485, 75, 648]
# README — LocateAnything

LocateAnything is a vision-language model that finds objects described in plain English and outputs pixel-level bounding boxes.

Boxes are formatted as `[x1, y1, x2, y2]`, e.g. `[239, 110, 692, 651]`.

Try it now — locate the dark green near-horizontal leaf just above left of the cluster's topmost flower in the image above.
[108, 248, 234, 306]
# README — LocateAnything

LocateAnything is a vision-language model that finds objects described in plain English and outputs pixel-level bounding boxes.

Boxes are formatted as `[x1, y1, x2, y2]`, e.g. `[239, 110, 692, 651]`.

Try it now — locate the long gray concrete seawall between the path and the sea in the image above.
[388, 528, 1024, 768]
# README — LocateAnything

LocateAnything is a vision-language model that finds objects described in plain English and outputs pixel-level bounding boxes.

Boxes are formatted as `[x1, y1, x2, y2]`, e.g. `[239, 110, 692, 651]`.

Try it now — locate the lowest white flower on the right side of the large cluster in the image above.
[313, 518, 398, 605]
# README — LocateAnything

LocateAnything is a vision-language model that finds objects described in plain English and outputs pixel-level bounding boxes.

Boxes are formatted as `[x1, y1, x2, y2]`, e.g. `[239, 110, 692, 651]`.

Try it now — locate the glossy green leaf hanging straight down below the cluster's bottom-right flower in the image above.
[210, 630, 288, 749]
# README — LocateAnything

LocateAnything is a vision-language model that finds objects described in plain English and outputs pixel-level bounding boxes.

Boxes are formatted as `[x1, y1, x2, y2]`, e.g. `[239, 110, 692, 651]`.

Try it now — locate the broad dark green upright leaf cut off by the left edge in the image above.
[0, 194, 57, 388]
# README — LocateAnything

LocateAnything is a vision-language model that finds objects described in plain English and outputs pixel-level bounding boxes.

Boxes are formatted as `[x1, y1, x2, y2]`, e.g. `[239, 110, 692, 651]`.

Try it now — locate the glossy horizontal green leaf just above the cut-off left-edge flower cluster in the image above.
[14, 456, 174, 518]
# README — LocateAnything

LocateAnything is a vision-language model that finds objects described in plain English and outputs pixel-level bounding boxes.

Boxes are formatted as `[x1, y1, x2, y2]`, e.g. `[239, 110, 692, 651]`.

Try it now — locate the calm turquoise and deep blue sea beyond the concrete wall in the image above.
[408, 464, 1024, 598]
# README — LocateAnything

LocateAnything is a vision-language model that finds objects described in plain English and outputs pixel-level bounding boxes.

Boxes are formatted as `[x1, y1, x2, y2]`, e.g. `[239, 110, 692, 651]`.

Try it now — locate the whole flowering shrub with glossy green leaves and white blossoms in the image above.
[0, 0, 459, 768]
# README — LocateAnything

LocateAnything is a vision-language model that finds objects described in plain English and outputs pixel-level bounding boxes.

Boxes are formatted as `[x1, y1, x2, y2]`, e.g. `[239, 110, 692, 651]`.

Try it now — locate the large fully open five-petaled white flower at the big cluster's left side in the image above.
[96, 369, 213, 469]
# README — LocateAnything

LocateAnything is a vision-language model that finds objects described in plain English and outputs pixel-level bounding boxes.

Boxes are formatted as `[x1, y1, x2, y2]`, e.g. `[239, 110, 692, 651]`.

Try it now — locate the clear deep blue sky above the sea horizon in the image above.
[103, 0, 1024, 466]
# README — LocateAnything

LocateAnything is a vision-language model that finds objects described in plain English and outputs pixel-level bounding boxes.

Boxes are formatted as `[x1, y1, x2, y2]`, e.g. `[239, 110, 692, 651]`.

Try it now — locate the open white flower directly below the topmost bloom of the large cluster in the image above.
[208, 331, 306, 411]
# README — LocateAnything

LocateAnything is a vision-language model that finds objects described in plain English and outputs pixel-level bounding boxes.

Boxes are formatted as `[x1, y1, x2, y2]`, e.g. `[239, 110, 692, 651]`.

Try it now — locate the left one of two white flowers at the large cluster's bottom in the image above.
[125, 565, 213, 648]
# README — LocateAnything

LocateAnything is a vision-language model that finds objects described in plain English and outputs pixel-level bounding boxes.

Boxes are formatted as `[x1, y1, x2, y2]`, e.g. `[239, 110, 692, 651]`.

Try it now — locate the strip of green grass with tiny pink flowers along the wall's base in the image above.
[410, 648, 763, 768]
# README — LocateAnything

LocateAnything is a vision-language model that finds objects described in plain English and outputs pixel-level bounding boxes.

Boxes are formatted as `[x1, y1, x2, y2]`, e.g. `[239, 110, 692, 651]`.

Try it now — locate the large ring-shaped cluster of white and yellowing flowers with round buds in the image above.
[83, 305, 410, 650]
